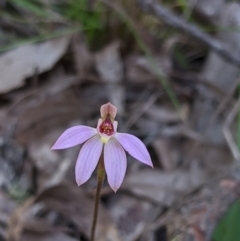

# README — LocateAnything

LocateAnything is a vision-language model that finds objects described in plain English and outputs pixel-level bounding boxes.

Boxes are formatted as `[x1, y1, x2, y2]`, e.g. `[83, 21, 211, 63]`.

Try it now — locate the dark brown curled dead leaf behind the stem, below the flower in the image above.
[37, 185, 121, 241]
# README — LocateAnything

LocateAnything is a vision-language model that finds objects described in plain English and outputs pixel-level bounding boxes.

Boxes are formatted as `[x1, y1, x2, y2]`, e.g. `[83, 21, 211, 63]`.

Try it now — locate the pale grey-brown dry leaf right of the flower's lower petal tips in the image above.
[122, 163, 204, 206]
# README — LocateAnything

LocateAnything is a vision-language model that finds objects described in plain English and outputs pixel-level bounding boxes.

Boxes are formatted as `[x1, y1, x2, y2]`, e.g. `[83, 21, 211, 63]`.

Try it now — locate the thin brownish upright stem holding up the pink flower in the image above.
[90, 156, 105, 241]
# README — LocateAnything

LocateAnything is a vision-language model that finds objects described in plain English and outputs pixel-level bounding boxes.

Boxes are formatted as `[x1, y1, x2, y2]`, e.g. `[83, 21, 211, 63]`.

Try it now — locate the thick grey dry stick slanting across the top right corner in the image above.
[137, 0, 240, 67]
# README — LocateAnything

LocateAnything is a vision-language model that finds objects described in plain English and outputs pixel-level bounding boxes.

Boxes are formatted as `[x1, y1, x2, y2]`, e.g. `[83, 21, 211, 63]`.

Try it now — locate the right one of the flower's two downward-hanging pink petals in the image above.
[104, 138, 127, 192]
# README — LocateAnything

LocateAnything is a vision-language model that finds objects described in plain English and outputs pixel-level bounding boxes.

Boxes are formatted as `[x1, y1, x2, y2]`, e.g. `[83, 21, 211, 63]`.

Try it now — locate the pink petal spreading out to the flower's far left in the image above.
[52, 126, 97, 150]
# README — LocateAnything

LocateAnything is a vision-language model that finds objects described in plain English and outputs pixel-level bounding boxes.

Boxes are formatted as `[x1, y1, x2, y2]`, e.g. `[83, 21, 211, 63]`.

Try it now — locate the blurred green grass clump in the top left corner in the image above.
[0, 0, 106, 52]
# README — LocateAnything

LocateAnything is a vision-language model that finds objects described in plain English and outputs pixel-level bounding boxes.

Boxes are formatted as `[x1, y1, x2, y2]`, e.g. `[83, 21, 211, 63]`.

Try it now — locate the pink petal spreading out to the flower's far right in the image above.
[114, 133, 153, 167]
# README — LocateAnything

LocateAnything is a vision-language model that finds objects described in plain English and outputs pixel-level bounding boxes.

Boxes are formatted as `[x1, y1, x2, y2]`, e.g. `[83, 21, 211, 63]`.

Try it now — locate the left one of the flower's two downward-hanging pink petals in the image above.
[75, 135, 103, 186]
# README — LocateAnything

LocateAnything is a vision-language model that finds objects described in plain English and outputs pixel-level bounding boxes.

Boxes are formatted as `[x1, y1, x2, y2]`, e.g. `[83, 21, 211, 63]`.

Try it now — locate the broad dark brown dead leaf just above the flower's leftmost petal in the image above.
[16, 87, 92, 145]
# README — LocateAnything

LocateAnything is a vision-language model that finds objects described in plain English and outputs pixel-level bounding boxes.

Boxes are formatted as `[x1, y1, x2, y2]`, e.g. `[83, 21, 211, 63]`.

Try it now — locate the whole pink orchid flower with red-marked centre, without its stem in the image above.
[52, 103, 153, 192]
